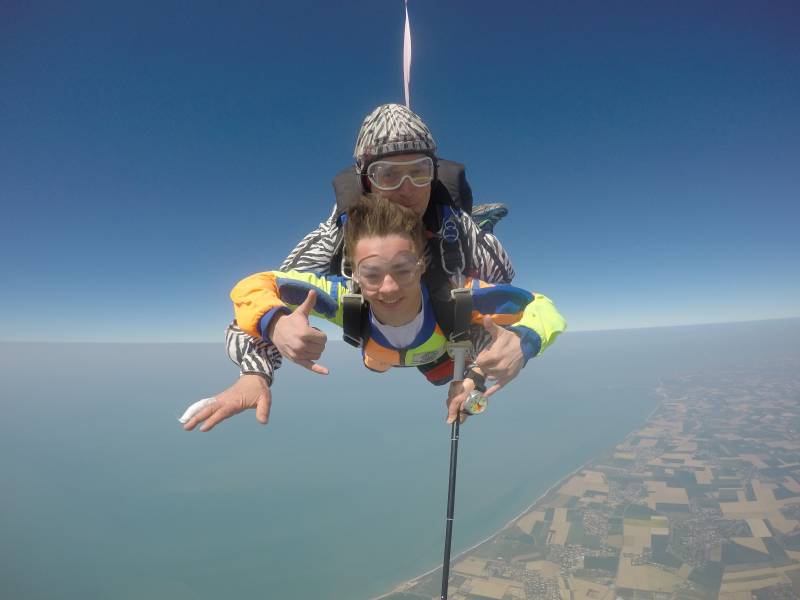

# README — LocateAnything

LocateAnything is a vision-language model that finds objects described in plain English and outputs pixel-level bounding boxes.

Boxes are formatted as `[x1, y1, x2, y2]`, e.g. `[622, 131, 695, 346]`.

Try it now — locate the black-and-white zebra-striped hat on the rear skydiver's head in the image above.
[353, 104, 436, 174]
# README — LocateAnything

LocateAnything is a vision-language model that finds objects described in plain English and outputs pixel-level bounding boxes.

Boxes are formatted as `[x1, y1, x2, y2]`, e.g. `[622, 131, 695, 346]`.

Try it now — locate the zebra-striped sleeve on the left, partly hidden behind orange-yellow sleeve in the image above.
[225, 206, 337, 385]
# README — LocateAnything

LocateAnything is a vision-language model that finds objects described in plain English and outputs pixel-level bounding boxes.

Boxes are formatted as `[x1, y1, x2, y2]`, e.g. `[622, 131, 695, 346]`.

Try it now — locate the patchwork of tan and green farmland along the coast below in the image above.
[383, 360, 800, 600]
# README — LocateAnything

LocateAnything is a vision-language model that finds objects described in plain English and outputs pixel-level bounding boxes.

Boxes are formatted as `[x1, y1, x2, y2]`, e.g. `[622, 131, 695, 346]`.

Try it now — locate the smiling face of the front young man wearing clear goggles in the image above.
[353, 235, 424, 327]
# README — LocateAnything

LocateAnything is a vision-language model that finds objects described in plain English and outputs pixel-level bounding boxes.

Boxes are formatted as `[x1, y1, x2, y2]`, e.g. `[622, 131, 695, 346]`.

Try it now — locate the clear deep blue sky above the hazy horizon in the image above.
[0, 0, 800, 343]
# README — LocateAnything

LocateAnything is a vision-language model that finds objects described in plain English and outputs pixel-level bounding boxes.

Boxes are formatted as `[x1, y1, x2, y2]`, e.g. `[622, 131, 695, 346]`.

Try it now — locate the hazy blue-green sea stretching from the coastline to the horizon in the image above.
[0, 319, 800, 600]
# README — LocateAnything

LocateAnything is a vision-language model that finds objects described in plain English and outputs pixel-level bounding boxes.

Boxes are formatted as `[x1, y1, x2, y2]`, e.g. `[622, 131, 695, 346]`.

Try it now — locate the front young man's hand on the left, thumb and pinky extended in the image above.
[268, 290, 328, 375]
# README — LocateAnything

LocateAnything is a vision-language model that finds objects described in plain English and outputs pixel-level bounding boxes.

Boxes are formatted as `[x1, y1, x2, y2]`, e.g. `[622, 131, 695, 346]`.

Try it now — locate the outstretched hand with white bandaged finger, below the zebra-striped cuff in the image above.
[178, 375, 272, 431]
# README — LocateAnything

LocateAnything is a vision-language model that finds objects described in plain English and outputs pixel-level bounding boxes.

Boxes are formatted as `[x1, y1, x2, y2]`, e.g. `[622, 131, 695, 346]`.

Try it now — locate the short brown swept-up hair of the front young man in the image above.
[344, 194, 425, 258]
